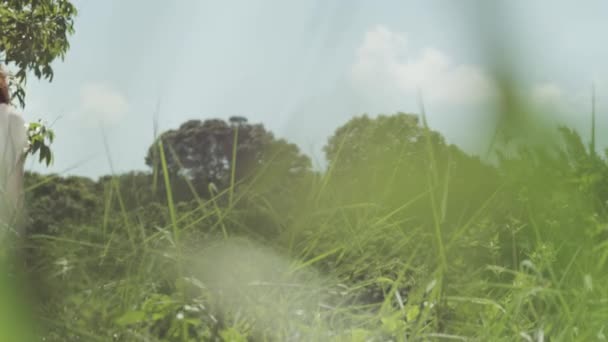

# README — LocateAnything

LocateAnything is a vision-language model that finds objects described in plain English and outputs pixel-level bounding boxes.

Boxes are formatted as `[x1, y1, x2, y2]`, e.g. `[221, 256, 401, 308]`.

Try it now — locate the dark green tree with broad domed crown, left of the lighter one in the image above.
[146, 117, 311, 202]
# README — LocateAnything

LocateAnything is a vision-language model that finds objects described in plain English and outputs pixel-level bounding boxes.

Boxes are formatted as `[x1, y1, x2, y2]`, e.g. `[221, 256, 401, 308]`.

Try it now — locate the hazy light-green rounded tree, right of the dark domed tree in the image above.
[324, 113, 497, 228]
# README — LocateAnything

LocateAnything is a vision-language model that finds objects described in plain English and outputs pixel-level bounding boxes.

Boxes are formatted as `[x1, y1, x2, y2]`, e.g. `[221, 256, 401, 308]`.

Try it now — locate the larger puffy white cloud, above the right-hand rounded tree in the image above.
[351, 26, 496, 105]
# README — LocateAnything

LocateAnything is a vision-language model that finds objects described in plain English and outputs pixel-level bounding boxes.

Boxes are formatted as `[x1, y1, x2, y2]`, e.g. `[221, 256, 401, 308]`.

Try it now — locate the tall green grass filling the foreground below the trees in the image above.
[8, 147, 608, 341]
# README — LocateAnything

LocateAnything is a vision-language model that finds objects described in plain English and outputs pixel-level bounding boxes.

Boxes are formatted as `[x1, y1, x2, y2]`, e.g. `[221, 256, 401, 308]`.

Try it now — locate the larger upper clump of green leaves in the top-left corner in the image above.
[0, 0, 77, 106]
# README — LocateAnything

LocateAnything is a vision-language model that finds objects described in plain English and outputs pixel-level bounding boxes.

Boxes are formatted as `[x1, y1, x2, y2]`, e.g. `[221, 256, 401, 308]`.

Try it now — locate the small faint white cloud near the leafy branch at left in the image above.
[79, 83, 129, 124]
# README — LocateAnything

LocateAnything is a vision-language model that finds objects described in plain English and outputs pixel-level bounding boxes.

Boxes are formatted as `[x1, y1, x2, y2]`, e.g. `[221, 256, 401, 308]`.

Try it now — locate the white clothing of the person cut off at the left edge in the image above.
[0, 104, 28, 240]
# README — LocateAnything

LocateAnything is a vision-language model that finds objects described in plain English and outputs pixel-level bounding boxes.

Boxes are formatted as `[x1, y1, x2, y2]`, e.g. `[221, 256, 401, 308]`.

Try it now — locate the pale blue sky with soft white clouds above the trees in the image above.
[23, 0, 608, 177]
